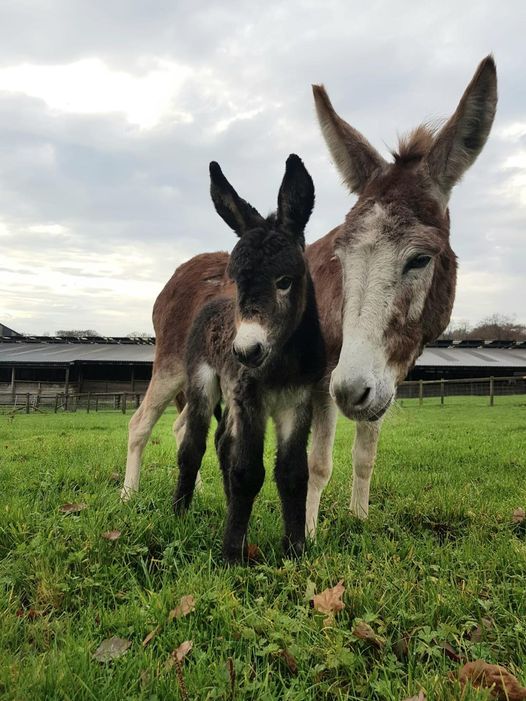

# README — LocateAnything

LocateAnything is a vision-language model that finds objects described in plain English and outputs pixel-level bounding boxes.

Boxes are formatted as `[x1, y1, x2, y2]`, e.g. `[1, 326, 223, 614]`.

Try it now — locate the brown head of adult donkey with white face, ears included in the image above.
[313, 56, 497, 421]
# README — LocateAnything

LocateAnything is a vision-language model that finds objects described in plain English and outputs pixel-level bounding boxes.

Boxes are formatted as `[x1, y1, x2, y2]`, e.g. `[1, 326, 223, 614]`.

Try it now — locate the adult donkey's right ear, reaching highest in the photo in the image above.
[427, 55, 497, 196]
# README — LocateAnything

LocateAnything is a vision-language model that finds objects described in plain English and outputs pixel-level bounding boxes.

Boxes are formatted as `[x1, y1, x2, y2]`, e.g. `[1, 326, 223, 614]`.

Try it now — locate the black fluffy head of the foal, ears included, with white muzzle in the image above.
[210, 154, 314, 367]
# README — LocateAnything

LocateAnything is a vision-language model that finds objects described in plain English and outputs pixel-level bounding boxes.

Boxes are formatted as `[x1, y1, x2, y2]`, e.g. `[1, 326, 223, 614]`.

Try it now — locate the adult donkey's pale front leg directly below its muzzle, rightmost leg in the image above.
[350, 419, 382, 519]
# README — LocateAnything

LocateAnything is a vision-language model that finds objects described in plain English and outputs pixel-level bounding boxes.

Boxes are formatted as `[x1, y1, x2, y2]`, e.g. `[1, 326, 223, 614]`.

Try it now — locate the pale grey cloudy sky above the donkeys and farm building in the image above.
[0, 0, 526, 335]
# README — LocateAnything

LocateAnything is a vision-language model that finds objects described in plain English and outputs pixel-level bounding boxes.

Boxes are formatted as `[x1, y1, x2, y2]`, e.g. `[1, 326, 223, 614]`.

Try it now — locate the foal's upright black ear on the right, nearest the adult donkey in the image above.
[277, 153, 314, 246]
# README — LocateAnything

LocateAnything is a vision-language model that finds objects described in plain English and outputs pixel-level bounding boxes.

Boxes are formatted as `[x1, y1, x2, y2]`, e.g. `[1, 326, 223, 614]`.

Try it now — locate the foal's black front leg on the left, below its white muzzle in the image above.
[223, 403, 265, 563]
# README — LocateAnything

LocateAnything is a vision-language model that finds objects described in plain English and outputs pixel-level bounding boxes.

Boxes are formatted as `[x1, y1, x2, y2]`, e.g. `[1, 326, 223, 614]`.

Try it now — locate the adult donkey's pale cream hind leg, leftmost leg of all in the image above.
[121, 369, 184, 501]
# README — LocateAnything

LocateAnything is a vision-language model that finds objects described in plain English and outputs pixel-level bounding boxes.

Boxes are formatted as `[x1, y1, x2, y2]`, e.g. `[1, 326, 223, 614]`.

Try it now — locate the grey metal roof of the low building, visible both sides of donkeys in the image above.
[0, 342, 526, 368]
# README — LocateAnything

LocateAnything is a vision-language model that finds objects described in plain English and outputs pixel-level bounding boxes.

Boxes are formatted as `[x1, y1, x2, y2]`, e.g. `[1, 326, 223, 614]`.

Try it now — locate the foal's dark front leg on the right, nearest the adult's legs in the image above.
[274, 401, 312, 557]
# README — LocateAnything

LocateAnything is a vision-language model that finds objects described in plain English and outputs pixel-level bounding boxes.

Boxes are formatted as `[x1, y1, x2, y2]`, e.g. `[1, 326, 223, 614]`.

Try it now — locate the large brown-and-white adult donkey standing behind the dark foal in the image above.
[123, 56, 497, 534]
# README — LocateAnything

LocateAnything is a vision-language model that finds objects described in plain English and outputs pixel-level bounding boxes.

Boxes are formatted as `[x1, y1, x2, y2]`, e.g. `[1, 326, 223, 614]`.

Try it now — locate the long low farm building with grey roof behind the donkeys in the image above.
[0, 335, 526, 395]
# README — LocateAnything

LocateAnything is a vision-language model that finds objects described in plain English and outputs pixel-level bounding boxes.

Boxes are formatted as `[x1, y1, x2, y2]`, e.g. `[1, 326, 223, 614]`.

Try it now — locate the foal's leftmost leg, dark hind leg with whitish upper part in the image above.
[173, 365, 220, 513]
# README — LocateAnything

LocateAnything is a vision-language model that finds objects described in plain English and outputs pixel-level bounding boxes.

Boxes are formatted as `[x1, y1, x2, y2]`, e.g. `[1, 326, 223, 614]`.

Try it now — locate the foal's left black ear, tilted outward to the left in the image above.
[210, 161, 264, 236]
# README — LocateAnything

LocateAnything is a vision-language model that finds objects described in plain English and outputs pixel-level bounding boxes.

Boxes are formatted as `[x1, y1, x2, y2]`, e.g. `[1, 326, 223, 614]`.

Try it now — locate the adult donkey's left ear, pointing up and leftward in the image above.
[312, 85, 387, 194]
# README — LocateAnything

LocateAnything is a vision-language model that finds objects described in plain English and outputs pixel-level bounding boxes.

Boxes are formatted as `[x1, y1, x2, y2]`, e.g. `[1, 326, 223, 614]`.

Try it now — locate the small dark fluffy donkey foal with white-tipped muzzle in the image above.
[174, 154, 325, 562]
